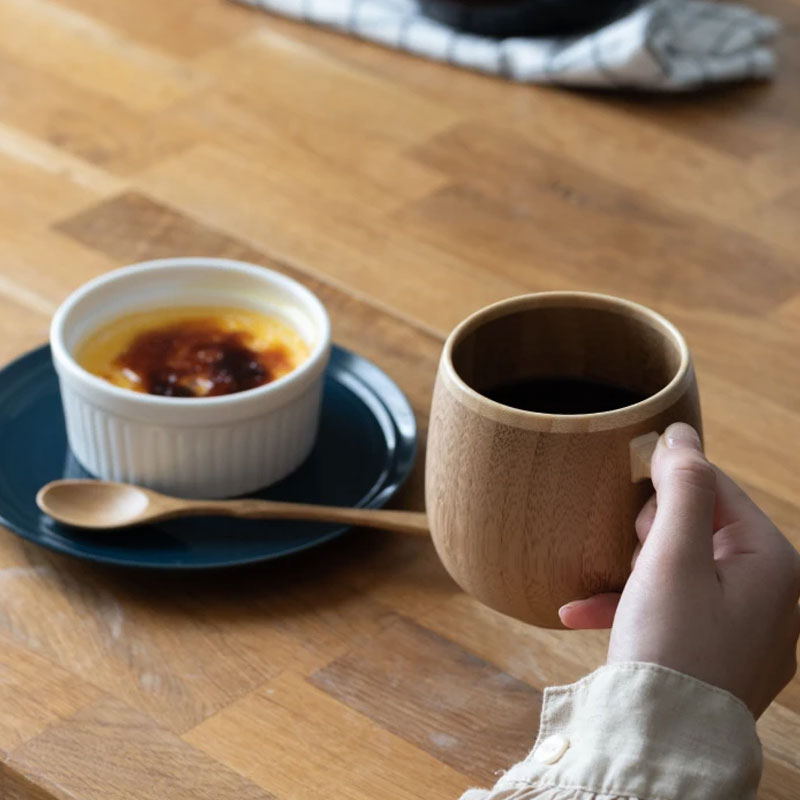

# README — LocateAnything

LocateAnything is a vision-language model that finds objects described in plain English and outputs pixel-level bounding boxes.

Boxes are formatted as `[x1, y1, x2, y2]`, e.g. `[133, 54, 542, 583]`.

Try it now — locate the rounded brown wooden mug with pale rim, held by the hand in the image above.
[425, 292, 702, 628]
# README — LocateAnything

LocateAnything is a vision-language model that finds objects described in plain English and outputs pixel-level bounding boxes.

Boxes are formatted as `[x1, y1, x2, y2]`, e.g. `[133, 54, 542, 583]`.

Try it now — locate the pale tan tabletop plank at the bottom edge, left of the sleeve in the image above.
[183, 672, 467, 800]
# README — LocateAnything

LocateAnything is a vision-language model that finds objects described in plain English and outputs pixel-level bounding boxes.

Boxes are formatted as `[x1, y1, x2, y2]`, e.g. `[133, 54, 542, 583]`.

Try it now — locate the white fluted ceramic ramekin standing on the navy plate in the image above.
[50, 258, 331, 497]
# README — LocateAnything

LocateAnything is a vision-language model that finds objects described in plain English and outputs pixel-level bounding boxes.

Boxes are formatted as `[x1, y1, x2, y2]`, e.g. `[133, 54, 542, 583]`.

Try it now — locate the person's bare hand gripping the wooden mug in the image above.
[559, 423, 800, 717]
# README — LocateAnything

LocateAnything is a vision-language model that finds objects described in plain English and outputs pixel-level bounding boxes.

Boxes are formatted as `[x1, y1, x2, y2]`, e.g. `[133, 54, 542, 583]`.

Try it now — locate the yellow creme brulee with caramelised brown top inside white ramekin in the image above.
[75, 306, 309, 397]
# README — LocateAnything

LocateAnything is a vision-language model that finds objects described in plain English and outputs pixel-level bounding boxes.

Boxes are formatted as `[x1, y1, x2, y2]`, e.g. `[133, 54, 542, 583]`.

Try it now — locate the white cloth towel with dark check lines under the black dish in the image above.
[234, 0, 778, 91]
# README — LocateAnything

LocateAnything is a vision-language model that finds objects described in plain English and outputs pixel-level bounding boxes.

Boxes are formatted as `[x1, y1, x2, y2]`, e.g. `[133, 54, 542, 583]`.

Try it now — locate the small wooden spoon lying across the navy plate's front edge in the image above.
[36, 480, 429, 536]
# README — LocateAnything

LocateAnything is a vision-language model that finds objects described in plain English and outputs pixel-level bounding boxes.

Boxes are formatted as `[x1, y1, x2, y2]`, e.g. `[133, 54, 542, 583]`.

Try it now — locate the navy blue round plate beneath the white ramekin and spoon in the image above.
[0, 346, 417, 569]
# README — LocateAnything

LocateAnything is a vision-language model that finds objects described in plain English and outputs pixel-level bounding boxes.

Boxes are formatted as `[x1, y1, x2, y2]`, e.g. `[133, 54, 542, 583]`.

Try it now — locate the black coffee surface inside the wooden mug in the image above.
[483, 375, 646, 414]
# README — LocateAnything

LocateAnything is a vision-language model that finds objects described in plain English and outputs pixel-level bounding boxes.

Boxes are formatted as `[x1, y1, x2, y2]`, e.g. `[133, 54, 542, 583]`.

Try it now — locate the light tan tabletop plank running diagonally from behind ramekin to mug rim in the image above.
[137, 145, 523, 335]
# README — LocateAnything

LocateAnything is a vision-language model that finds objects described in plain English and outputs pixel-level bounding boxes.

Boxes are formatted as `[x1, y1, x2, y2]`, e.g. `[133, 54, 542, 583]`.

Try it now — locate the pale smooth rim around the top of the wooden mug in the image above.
[439, 291, 694, 433]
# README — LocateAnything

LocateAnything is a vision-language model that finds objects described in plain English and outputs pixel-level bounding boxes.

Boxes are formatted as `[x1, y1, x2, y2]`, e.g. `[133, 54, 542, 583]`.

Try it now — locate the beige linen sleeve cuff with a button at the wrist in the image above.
[461, 663, 761, 800]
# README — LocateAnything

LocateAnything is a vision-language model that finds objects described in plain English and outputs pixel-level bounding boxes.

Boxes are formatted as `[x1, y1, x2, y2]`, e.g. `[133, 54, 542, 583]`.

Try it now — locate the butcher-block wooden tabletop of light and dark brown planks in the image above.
[0, 0, 800, 800]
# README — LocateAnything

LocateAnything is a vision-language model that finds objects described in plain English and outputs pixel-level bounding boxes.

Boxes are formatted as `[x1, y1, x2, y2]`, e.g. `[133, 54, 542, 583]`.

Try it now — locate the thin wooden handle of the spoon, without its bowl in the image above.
[162, 498, 430, 536]
